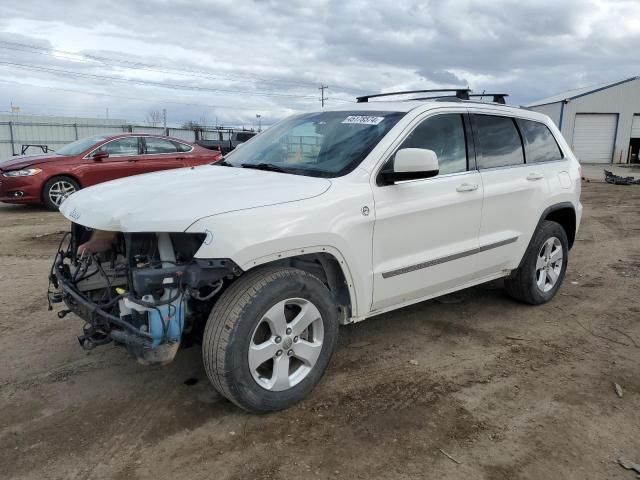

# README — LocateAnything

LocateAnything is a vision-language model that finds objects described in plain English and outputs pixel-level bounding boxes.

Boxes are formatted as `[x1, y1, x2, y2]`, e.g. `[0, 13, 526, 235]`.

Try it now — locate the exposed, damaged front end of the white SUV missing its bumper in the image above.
[48, 223, 242, 363]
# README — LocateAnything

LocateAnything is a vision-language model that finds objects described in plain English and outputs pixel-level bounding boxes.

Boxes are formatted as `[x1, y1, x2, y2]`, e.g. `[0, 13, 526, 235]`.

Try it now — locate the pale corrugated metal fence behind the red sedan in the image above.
[0, 114, 248, 159]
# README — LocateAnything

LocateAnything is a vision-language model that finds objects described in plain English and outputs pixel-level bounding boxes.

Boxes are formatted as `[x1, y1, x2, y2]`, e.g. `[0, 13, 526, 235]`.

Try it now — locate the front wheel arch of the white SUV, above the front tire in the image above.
[241, 246, 357, 323]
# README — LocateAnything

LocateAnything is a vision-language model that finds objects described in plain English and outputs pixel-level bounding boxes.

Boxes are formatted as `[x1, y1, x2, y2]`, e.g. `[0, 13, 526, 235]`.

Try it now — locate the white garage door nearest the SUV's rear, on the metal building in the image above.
[573, 113, 618, 163]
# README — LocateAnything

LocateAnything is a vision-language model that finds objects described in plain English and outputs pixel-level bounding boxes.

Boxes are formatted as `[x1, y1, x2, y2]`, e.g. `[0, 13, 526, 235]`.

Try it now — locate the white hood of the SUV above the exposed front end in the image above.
[60, 165, 331, 232]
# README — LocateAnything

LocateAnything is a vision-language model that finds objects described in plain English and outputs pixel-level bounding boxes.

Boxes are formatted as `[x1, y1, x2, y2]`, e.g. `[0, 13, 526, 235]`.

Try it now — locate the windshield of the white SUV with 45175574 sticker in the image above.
[224, 111, 405, 177]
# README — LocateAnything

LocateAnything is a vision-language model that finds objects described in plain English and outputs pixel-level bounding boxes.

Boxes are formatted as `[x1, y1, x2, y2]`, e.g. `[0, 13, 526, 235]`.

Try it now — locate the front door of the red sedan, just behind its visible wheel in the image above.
[82, 136, 142, 187]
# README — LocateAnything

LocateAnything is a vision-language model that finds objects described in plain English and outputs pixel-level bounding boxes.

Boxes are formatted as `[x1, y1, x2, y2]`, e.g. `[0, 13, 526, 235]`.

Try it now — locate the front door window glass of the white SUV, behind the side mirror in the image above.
[400, 114, 467, 175]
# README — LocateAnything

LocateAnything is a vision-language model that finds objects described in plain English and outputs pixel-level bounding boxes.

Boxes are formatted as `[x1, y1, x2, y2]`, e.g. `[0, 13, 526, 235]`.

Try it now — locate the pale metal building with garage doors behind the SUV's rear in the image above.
[527, 77, 640, 163]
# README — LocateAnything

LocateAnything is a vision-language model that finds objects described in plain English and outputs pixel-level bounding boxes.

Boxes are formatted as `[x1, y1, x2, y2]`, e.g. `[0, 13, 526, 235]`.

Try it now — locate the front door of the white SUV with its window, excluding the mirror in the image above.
[372, 112, 483, 311]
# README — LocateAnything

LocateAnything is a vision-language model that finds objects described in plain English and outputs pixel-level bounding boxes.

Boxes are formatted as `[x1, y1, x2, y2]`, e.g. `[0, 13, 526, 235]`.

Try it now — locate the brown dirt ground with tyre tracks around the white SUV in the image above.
[0, 183, 640, 480]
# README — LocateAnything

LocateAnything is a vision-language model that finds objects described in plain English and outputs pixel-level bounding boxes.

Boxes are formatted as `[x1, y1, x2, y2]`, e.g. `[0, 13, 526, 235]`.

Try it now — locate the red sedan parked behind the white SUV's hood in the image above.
[0, 133, 221, 210]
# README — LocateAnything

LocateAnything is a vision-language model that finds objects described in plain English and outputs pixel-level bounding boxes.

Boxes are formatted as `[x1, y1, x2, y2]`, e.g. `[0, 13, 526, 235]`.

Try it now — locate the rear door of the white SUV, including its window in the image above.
[471, 114, 549, 277]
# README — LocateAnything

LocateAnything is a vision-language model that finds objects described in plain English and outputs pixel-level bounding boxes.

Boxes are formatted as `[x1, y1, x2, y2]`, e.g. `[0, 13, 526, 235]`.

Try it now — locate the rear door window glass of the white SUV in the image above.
[473, 115, 524, 169]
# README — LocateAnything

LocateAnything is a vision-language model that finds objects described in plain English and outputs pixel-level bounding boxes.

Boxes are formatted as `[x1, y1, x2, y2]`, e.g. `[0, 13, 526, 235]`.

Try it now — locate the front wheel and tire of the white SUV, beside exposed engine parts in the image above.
[202, 267, 338, 413]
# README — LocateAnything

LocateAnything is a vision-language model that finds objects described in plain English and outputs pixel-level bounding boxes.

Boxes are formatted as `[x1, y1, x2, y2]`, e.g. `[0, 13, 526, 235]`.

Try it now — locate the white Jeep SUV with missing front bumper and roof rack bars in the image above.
[49, 91, 582, 411]
